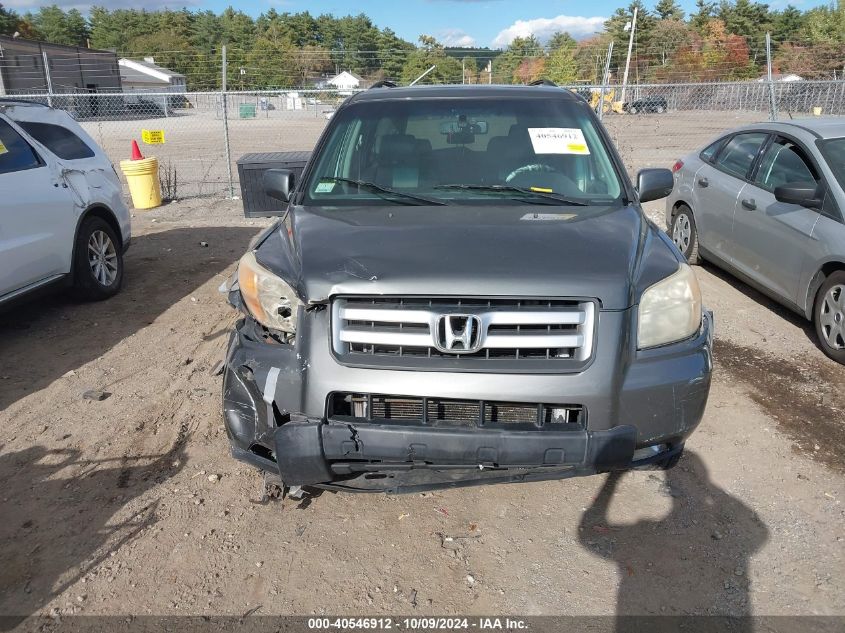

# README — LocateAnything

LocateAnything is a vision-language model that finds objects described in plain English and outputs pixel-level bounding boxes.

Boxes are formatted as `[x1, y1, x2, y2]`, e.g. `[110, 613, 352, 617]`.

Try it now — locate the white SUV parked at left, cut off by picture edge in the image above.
[0, 99, 131, 305]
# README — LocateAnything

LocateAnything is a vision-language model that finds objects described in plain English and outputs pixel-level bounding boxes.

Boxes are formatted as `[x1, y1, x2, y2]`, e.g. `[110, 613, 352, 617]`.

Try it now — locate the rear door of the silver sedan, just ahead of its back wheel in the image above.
[692, 132, 768, 263]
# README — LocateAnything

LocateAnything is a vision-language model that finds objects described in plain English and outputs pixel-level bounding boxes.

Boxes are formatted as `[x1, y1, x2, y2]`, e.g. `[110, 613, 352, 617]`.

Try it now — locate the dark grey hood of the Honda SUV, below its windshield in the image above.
[256, 205, 679, 310]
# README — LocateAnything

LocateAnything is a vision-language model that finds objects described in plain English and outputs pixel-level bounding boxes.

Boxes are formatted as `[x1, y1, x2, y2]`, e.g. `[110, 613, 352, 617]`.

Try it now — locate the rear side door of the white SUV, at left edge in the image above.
[0, 117, 76, 297]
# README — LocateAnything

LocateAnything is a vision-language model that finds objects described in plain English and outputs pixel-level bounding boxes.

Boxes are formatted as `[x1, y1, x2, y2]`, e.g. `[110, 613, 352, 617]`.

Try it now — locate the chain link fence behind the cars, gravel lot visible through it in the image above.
[4, 80, 845, 199]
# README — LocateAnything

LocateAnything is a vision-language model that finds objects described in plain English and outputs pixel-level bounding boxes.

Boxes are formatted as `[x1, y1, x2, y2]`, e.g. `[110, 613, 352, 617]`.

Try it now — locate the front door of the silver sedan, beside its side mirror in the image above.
[733, 136, 819, 303]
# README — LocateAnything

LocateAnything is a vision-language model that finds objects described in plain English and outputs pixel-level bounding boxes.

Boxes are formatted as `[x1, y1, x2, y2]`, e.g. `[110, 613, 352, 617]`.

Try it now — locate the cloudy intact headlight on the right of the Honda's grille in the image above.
[637, 264, 701, 349]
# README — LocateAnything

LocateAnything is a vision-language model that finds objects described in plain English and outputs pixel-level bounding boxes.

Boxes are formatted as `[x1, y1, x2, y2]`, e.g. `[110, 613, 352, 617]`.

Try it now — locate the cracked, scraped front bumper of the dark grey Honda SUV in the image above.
[223, 311, 712, 492]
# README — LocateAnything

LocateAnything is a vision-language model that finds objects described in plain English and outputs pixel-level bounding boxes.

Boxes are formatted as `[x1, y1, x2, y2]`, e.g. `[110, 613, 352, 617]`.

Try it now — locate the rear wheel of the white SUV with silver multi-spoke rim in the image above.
[73, 217, 123, 301]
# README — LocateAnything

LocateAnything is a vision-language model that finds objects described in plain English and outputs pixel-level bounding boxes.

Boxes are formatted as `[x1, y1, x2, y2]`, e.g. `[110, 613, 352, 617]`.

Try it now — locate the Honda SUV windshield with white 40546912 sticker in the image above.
[303, 98, 623, 207]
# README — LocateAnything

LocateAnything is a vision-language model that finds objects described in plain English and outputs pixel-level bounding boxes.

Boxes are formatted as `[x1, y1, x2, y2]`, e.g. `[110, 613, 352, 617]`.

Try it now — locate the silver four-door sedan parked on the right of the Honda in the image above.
[666, 118, 845, 364]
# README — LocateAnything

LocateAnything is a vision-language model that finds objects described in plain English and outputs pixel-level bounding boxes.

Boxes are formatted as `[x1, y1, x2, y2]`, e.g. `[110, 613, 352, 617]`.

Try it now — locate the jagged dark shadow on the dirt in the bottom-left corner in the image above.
[0, 432, 187, 630]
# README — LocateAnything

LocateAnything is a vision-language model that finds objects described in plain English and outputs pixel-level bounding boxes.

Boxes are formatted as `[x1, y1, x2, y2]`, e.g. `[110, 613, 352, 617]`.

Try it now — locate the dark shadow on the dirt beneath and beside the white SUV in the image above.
[0, 227, 257, 411]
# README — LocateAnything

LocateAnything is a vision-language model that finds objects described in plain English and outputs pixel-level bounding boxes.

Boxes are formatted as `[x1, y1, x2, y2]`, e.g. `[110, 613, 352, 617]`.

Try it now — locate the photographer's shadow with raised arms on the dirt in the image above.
[579, 451, 768, 632]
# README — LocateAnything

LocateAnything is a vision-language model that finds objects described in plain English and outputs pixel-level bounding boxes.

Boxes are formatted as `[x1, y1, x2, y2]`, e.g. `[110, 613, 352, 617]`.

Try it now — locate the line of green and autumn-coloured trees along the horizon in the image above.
[0, 0, 845, 90]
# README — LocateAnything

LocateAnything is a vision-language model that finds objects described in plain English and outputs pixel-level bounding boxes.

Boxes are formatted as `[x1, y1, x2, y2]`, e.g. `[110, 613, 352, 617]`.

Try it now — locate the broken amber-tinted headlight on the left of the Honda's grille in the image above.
[238, 251, 302, 334]
